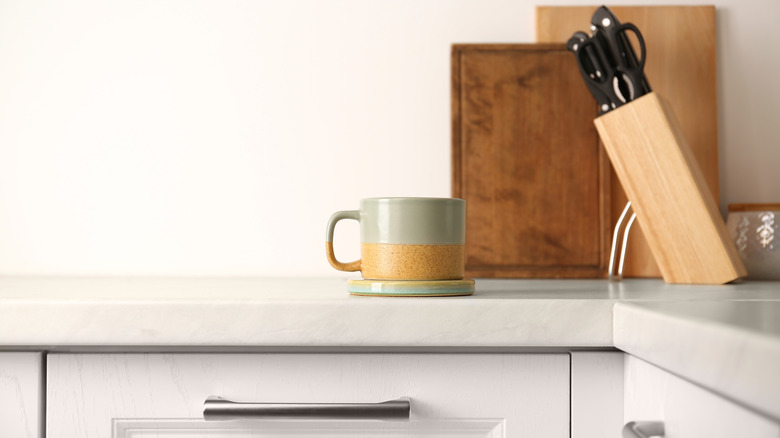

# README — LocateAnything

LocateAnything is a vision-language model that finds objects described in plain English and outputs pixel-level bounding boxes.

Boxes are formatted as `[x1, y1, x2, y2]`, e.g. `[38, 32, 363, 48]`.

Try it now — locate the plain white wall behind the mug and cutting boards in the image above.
[0, 0, 780, 275]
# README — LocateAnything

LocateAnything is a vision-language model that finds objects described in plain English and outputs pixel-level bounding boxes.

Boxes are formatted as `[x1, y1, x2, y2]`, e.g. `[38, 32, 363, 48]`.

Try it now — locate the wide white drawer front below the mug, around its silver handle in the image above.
[47, 353, 569, 438]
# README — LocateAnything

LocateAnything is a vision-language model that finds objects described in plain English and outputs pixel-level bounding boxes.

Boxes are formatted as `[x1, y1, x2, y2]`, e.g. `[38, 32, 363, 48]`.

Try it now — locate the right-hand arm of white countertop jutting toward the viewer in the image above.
[614, 301, 780, 419]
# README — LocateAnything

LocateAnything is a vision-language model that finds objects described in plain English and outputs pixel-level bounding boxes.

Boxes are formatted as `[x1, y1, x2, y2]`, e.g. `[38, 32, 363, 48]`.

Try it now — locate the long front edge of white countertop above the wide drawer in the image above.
[0, 298, 614, 348]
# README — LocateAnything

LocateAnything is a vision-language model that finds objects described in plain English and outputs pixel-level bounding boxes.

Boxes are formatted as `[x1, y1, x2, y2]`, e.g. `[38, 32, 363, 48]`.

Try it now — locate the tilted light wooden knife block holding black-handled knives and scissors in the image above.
[594, 93, 747, 284]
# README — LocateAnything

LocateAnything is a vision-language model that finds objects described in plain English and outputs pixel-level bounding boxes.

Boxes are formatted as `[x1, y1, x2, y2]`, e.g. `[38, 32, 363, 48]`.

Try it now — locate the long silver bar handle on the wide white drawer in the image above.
[203, 395, 412, 420]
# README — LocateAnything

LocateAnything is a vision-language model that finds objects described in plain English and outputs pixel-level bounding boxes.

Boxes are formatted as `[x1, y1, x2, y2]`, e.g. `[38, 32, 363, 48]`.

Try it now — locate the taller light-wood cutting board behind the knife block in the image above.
[536, 6, 720, 277]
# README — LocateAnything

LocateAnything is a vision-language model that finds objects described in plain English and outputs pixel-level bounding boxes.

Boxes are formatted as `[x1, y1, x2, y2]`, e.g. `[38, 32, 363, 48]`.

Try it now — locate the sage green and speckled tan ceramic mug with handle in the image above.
[325, 198, 466, 280]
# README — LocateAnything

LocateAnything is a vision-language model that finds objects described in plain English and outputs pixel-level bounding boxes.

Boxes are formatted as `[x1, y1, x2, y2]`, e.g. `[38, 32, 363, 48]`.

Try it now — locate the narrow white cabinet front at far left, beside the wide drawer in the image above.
[0, 353, 44, 438]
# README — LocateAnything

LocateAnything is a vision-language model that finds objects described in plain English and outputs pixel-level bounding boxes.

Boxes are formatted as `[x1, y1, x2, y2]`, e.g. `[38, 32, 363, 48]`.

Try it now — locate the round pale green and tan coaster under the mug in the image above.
[347, 280, 474, 297]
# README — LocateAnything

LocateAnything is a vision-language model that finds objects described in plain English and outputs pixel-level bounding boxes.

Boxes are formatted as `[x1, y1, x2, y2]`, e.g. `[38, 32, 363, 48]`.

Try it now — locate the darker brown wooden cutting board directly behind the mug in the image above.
[452, 44, 609, 278]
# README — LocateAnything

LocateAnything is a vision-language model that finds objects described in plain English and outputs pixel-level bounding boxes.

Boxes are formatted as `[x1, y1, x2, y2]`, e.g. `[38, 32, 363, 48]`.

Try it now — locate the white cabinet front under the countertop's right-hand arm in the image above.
[624, 353, 780, 438]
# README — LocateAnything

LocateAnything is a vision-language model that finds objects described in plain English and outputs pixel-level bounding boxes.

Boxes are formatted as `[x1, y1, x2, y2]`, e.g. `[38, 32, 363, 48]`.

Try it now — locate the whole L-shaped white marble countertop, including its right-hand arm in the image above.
[0, 277, 780, 418]
